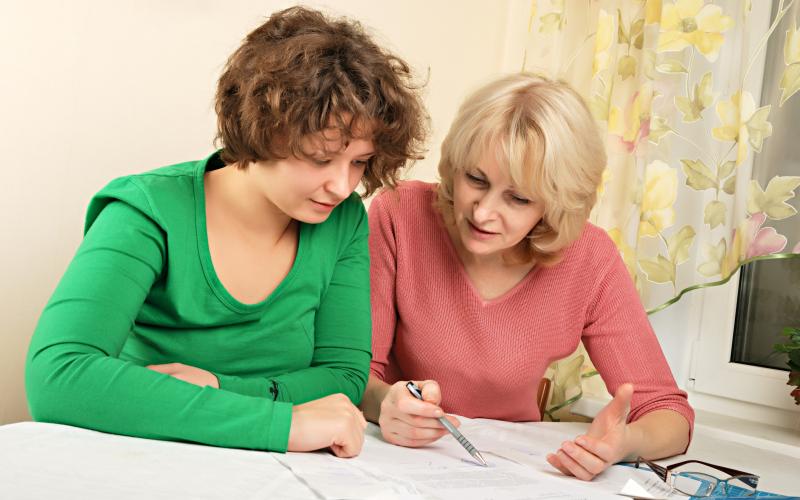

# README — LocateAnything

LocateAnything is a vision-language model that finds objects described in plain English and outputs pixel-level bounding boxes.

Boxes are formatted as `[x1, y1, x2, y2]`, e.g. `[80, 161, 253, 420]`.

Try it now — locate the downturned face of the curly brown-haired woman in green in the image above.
[248, 129, 375, 224]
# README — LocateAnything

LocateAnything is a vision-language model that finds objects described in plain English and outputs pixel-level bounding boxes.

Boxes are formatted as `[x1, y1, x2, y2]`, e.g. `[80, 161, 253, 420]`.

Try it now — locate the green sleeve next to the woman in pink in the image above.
[218, 199, 372, 404]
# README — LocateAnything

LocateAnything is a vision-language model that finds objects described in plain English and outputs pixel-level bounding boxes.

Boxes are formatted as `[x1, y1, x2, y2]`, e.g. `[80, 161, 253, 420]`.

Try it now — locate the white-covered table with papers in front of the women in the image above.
[0, 419, 800, 500]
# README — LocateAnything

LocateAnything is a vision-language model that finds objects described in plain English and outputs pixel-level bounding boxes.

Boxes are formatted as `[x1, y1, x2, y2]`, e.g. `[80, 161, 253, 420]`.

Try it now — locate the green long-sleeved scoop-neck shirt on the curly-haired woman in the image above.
[26, 154, 371, 451]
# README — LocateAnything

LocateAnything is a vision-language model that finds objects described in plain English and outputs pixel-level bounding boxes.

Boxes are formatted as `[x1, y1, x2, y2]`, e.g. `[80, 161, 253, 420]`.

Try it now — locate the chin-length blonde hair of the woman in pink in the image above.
[437, 73, 606, 265]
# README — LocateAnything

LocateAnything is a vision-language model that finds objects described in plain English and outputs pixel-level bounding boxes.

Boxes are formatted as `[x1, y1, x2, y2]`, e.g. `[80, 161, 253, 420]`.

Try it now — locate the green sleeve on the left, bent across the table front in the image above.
[26, 202, 291, 451]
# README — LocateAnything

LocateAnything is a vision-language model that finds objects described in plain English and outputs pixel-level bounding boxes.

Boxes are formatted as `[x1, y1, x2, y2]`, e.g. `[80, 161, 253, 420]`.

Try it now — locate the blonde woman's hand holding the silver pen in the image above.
[378, 380, 461, 448]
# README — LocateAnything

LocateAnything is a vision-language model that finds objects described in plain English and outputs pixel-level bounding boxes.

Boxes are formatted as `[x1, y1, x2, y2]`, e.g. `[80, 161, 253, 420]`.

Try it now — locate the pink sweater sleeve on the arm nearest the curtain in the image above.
[583, 237, 694, 434]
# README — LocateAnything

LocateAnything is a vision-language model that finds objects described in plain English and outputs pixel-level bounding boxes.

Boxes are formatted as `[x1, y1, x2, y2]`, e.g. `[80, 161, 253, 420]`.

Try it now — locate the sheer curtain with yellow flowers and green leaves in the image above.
[522, 0, 800, 419]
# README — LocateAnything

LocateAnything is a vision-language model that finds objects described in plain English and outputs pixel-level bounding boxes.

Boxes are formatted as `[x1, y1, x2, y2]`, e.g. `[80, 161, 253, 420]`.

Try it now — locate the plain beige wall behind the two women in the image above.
[0, 0, 528, 424]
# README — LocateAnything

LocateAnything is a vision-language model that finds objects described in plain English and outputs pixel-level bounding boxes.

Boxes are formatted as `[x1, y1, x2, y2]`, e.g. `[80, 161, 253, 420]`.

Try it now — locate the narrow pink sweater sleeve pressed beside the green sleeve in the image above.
[369, 192, 397, 380]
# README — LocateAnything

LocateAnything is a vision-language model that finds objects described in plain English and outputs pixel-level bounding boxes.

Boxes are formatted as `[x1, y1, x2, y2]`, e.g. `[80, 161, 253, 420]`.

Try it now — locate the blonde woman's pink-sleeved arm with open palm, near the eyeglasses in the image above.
[548, 235, 694, 479]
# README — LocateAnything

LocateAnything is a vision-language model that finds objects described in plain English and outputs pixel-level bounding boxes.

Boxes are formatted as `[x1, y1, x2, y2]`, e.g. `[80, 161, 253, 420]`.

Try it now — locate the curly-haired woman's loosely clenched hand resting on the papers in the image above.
[288, 394, 367, 458]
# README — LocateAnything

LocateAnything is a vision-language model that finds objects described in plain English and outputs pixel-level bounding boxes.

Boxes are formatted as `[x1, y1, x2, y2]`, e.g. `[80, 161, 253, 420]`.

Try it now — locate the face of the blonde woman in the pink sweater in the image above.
[453, 151, 544, 257]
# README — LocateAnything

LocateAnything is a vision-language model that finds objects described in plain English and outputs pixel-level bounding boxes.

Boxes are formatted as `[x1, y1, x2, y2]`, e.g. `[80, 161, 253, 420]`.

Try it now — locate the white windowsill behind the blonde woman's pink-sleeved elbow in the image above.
[572, 396, 800, 458]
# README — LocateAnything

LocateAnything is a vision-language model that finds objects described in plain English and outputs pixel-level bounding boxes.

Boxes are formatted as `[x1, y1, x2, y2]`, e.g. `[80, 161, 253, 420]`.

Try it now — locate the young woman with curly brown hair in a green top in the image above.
[26, 8, 425, 456]
